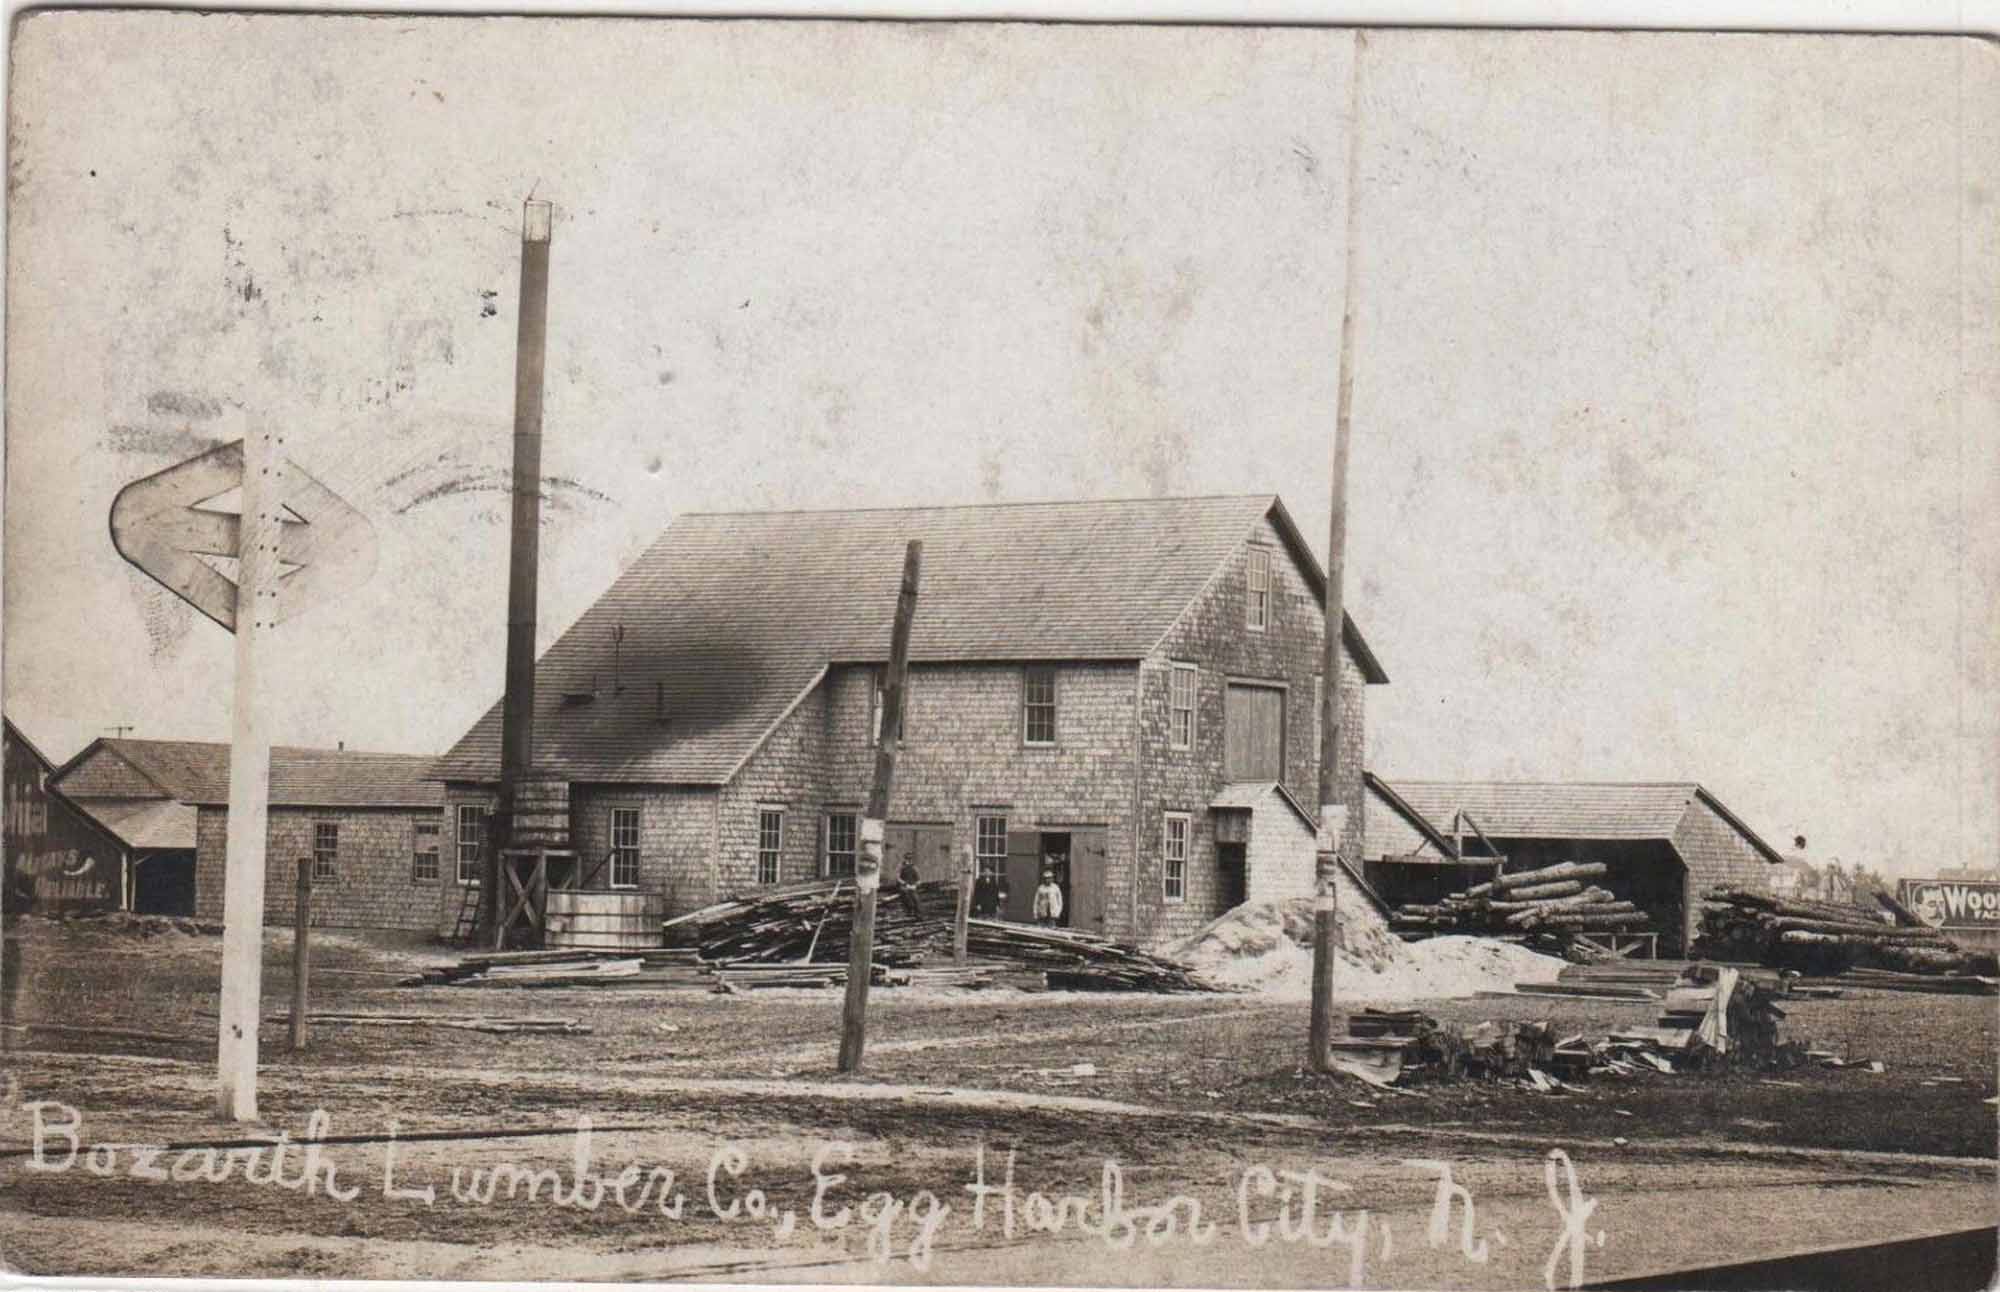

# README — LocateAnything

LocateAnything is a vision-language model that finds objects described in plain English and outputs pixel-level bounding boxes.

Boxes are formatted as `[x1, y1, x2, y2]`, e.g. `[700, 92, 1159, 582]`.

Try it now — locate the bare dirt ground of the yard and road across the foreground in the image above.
[0, 920, 2000, 1286]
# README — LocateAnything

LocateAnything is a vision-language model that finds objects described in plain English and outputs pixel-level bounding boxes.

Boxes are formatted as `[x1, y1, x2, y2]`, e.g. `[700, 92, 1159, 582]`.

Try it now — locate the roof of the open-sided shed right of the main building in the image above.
[1394, 780, 1784, 862]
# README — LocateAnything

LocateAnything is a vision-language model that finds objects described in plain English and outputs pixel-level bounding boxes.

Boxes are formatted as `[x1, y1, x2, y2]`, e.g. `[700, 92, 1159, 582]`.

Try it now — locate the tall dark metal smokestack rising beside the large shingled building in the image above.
[480, 198, 554, 940]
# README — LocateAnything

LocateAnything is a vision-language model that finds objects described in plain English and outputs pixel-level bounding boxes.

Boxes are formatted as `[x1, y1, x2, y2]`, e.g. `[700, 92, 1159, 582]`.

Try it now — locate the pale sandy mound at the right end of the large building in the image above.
[1168, 892, 1564, 1000]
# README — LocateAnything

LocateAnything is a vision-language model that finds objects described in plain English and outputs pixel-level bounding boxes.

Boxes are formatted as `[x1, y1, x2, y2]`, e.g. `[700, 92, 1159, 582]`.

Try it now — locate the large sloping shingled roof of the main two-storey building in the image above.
[432, 494, 1388, 784]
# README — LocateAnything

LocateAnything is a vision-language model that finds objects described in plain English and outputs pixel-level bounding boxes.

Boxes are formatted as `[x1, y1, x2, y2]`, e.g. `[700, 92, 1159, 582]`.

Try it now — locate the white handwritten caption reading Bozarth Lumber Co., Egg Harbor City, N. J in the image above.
[20, 1100, 1604, 1288]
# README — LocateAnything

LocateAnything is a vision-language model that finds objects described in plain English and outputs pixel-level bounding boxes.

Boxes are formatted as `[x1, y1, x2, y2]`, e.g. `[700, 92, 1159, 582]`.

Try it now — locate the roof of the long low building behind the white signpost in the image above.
[50, 736, 444, 808]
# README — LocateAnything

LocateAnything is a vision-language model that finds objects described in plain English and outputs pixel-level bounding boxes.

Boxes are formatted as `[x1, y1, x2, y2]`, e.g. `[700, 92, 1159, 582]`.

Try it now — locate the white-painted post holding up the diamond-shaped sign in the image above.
[216, 424, 284, 1122]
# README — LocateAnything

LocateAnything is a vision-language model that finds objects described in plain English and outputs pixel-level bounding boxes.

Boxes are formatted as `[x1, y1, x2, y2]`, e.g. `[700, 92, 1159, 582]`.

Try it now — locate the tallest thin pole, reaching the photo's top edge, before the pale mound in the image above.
[1308, 28, 1368, 1072]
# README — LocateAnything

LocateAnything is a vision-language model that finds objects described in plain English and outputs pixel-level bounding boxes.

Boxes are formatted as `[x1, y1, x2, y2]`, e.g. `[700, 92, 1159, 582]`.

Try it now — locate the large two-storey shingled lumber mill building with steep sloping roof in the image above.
[434, 494, 1386, 938]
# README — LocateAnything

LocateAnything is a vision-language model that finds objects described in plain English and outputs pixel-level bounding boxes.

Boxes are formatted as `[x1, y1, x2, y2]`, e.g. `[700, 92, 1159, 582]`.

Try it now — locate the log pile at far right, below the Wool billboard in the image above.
[1692, 888, 1990, 976]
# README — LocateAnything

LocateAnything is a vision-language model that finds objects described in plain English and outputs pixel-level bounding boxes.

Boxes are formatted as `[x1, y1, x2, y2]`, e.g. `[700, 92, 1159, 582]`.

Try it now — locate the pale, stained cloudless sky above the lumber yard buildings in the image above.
[0, 12, 2000, 874]
